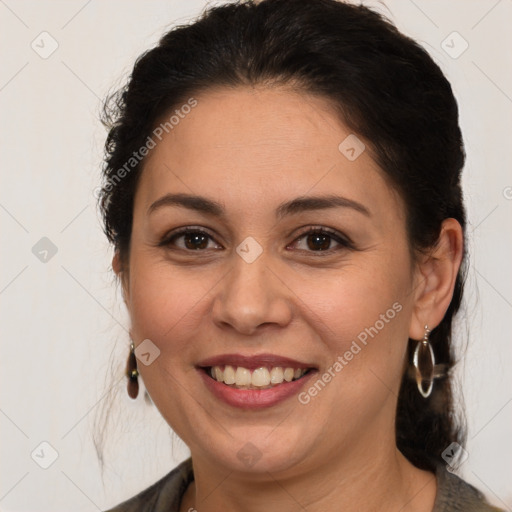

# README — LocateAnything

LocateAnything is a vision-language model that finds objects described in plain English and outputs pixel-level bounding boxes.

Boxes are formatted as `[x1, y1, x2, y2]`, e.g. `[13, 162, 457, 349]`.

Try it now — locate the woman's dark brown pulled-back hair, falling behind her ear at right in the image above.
[100, 0, 466, 470]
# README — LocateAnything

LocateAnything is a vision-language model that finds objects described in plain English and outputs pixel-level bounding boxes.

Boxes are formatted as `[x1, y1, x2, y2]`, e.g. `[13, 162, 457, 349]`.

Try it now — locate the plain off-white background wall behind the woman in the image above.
[0, 0, 512, 512]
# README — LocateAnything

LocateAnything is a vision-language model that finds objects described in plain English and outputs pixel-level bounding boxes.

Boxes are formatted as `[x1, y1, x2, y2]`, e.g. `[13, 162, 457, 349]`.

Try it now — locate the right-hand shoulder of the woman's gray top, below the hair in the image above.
[433, 465, 503, 512]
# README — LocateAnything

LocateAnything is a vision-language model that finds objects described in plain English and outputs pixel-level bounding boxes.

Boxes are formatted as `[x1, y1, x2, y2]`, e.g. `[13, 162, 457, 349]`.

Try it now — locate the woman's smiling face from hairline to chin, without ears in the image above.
[123, 87, 424, 474]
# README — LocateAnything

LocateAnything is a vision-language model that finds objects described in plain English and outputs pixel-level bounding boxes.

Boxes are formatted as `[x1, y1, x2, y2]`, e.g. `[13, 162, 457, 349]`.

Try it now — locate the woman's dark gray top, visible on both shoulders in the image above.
[106, 458, 504, 512]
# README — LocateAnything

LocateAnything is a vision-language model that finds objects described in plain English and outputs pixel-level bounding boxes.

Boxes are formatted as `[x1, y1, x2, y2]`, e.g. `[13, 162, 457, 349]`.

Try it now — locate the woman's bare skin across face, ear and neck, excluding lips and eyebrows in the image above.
[113, 86, 463, 512]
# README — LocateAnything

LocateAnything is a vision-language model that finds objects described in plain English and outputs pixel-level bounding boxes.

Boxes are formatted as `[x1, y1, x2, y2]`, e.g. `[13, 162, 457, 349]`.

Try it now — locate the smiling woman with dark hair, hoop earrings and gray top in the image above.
[101, 0, 504, 512]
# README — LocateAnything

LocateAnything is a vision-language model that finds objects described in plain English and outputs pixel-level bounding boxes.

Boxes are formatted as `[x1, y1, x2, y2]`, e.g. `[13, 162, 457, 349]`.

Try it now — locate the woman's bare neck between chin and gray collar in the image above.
[180, 436, 436, 512]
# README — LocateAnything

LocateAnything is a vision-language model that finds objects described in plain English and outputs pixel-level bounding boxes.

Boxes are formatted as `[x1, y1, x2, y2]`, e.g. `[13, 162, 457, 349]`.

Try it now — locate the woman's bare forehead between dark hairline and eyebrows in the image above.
[137, 87, 404, 222]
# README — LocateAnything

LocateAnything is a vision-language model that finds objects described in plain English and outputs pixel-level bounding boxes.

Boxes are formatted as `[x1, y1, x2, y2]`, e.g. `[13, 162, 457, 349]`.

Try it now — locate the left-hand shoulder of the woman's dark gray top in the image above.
[105, 458, 194, 512]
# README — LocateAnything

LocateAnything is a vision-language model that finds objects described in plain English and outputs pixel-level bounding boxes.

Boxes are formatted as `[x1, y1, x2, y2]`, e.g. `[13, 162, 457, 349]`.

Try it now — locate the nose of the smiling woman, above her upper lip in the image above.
[212, 252, 293, 336]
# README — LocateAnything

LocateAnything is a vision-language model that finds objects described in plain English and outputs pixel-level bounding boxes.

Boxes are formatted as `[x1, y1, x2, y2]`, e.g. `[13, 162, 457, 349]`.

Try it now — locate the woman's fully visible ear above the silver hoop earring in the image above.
[409, 218, 464, 340]
